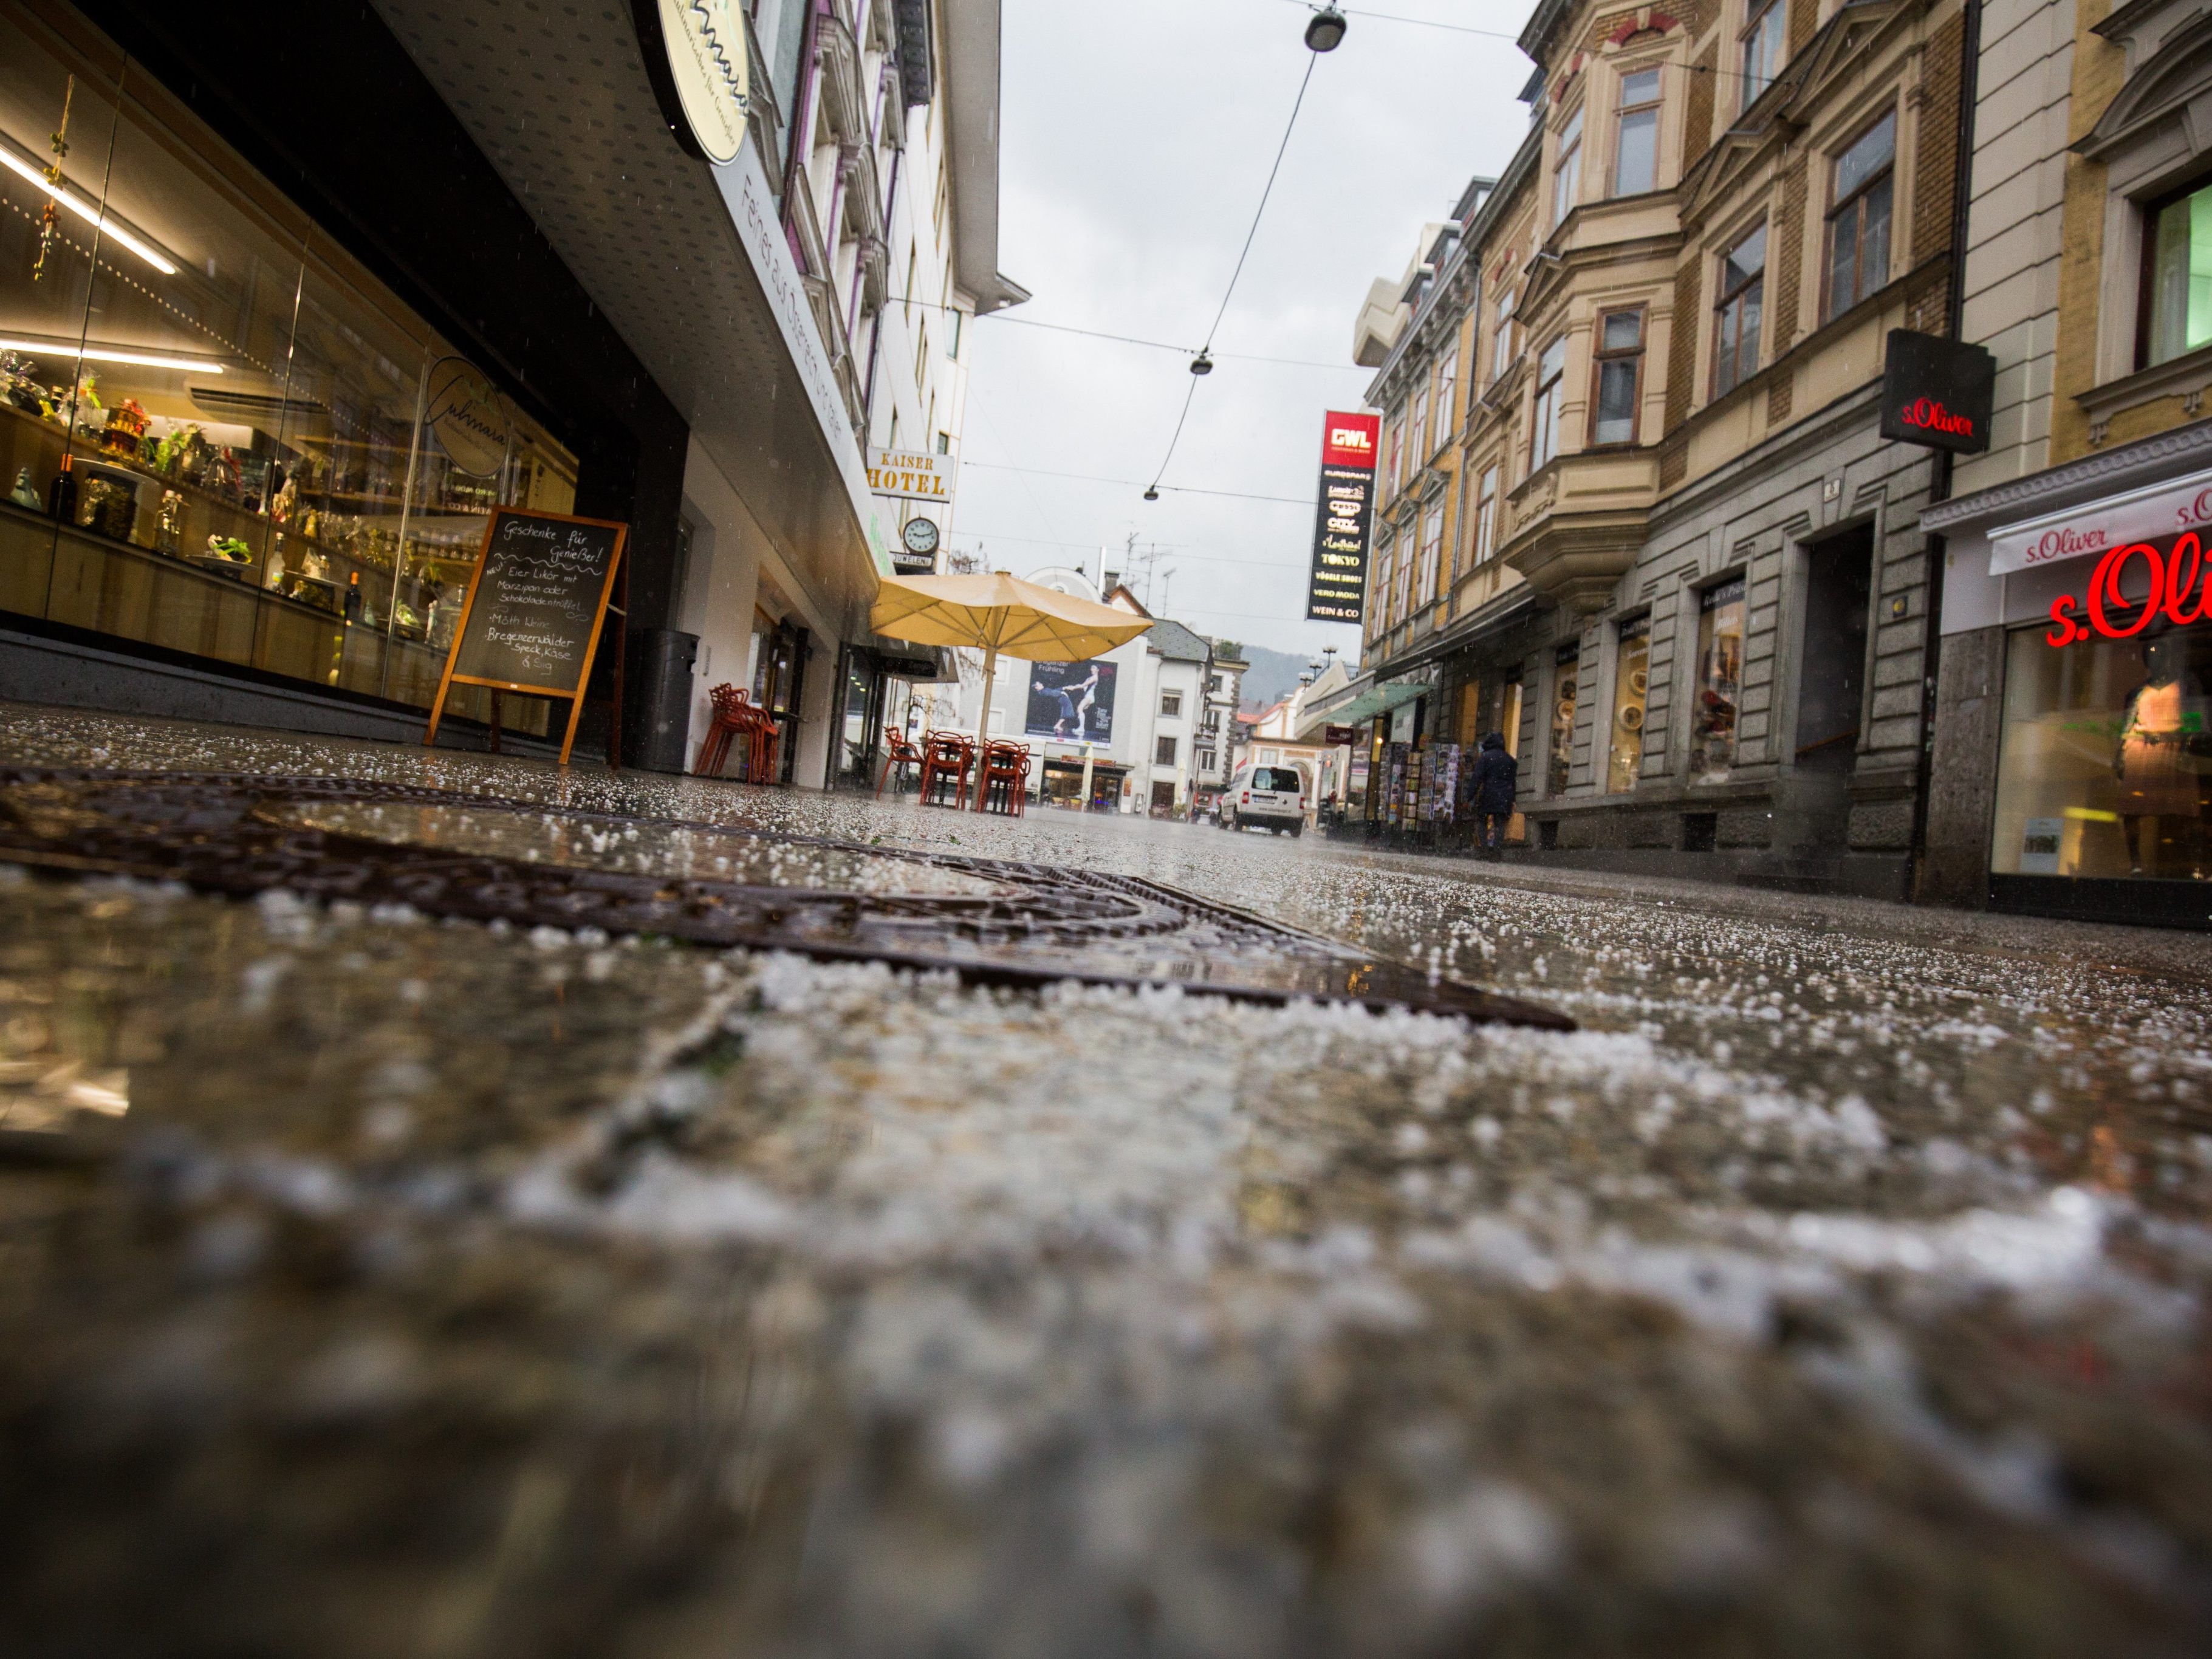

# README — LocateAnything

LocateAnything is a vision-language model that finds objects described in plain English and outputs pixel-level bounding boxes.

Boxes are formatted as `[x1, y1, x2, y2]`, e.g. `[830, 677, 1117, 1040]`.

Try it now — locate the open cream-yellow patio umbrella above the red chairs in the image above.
[867, 570, 1152, 812]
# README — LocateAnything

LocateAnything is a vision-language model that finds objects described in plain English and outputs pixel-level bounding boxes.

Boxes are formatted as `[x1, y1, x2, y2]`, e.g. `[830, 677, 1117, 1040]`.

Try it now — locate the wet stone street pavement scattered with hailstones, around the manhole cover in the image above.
[0, 706, 2212, 1657]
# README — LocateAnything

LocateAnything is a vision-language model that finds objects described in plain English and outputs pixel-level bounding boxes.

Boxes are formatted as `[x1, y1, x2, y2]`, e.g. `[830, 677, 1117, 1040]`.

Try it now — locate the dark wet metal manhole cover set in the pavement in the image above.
[0, 768, 1575, 1031]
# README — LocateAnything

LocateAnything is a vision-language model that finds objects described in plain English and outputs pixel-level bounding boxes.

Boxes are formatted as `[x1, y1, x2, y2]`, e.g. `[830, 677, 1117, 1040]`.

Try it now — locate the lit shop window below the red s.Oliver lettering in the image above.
[1988, 626, 2212, 883]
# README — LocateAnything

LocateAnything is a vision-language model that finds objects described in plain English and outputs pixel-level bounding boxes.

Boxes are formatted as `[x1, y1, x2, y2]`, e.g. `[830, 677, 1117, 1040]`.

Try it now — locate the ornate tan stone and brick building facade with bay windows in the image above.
[1369, 0, 1967, 894]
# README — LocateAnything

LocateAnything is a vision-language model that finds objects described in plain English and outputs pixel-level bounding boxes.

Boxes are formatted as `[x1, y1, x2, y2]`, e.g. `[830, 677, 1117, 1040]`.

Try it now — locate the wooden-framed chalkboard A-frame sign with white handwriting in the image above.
[422, 507, 631, 765]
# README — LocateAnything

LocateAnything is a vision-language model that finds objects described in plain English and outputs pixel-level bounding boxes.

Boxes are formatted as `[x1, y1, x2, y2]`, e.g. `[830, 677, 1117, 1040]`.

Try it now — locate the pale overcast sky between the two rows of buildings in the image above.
[951, 0, 1529, 657]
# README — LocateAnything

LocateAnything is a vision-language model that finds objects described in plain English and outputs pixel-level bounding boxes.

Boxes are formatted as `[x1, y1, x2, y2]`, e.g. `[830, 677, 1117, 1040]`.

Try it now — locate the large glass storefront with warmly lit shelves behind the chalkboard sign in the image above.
[0, 4, 577, 732]
